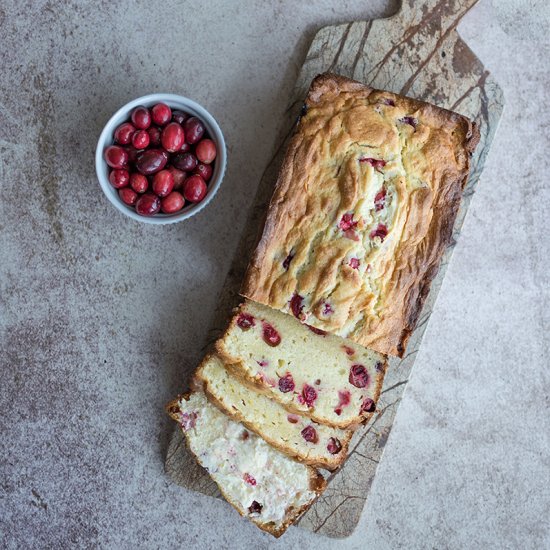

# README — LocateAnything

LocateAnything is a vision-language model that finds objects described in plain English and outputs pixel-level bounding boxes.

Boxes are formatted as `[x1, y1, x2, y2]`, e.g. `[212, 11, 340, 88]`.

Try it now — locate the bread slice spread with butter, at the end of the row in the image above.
[167, 392, 326, 537]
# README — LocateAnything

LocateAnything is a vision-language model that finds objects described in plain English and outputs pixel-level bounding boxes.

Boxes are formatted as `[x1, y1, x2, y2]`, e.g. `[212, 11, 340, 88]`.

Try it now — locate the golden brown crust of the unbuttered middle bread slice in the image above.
[193, 355, 353, 471]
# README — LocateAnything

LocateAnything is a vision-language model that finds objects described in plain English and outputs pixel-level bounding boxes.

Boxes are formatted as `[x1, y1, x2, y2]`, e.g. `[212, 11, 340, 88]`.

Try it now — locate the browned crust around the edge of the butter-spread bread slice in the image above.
[166, 393, 327, 538]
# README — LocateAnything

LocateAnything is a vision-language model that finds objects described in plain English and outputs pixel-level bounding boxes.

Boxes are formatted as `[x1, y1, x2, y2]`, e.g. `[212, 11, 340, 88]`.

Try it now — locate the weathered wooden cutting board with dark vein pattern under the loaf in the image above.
[166, 0, 503, 538]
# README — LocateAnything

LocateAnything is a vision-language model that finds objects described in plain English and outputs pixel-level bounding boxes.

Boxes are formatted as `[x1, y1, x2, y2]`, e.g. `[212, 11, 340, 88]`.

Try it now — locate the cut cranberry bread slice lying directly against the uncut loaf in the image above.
[216, 300, 386, 429]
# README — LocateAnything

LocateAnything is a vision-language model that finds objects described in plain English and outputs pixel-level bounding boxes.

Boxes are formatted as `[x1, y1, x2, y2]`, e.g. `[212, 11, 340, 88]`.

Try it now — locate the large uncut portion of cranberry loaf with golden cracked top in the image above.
[241, 74, 479, 356]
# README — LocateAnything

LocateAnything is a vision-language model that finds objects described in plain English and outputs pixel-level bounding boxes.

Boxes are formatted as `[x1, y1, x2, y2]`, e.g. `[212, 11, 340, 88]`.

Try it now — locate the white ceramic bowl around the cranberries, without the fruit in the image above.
[95, 94, 227, 225]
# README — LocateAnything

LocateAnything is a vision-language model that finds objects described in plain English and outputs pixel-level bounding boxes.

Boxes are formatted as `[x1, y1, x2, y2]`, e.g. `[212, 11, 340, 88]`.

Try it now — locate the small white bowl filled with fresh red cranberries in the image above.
[95, 94, 226, 224]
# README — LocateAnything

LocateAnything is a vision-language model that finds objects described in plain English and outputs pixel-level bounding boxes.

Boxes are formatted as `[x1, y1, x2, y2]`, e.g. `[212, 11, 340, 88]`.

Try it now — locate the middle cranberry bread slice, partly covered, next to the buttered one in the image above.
[193, 355, 353, 470]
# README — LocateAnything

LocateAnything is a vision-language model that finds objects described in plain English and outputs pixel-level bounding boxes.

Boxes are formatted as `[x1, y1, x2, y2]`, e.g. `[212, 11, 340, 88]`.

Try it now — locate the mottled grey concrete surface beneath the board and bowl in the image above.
[0, 0, 550, 549]
